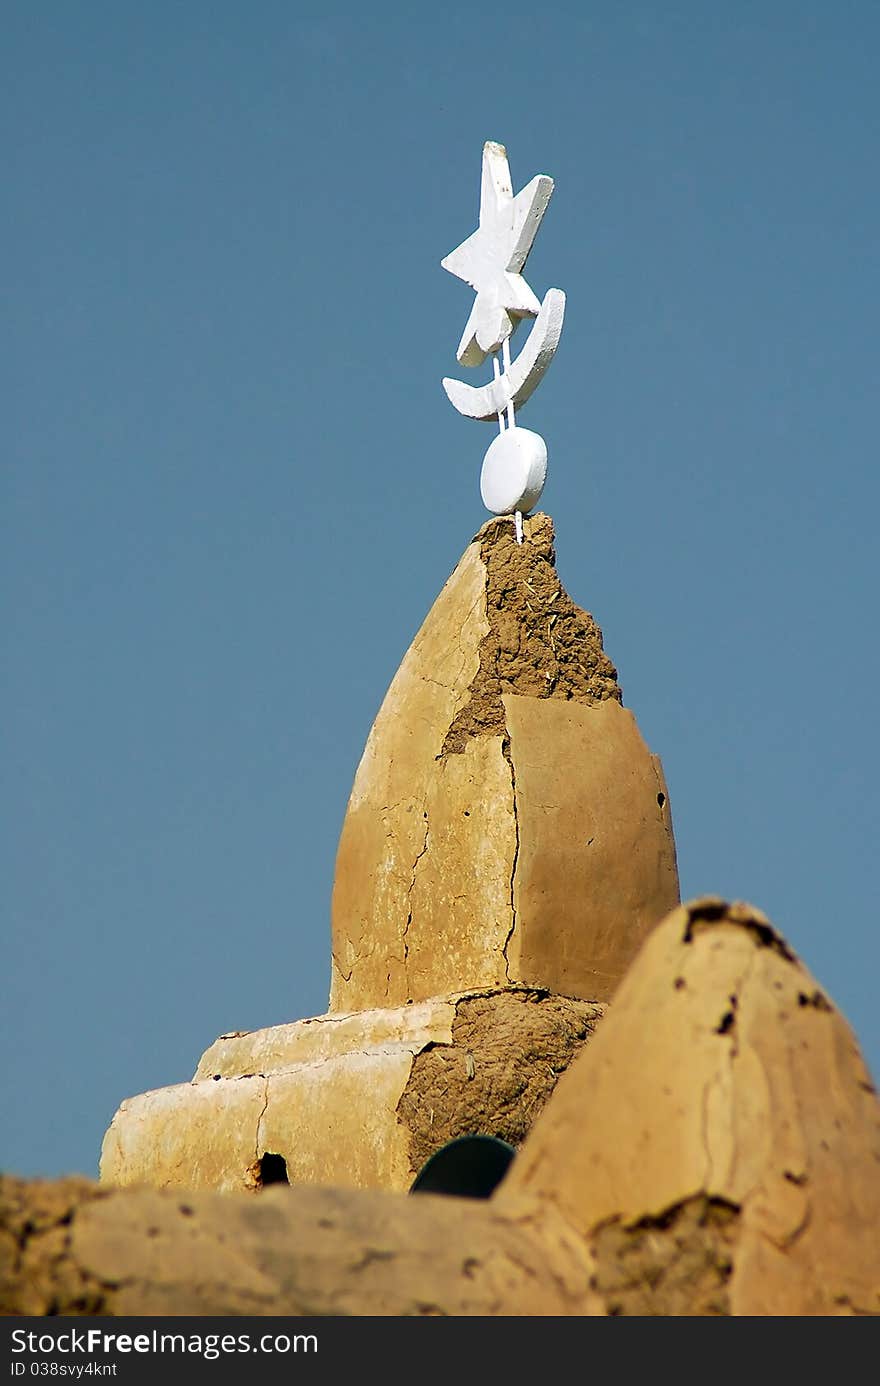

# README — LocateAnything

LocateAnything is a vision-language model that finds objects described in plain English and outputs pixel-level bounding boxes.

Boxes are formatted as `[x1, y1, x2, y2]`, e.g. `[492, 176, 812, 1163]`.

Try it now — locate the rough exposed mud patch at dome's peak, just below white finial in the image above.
[441, 514, 622, 755]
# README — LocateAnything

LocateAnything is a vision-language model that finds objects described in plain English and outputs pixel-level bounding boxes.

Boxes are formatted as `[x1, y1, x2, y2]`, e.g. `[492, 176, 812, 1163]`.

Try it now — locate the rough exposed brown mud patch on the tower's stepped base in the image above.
[398, 991, 603, 1175]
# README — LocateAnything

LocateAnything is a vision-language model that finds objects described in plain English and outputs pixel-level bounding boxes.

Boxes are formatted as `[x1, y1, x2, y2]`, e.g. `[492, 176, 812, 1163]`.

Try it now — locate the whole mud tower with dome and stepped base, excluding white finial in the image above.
[101, 514, 678, 1191]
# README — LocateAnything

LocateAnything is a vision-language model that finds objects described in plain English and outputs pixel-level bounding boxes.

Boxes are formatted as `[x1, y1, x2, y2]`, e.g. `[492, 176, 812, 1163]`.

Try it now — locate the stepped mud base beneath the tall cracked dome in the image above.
[101, 988, 603, 1193]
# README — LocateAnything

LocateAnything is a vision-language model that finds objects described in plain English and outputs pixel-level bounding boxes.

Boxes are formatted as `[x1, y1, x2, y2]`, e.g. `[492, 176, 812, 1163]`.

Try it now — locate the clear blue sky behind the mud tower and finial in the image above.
[0, 0, 880, 1174]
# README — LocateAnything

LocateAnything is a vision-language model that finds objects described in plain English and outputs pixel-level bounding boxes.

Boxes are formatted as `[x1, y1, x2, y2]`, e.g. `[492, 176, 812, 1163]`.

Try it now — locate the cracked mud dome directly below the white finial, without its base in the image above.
[330, 514, 679, 1010]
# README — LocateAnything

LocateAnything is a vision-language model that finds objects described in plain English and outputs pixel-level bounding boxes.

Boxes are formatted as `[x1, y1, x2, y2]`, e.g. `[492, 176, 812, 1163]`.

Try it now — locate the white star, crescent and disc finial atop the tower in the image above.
[441, 140, 565, 543]
